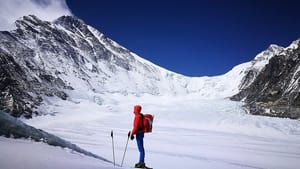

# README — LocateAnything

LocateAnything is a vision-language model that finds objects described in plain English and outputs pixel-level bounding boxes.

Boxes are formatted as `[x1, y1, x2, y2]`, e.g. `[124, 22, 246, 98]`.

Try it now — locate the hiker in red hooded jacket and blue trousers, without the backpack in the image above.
[130, 105, 147, 168]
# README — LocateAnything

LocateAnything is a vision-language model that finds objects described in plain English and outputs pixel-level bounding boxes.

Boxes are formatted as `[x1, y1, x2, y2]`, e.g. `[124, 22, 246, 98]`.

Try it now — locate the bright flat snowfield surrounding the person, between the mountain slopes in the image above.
[25, 94, 300, 169]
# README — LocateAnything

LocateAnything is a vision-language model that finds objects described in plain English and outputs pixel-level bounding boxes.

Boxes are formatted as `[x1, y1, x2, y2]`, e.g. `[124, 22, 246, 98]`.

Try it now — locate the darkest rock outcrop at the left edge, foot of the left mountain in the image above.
[0, 52, 41, 118]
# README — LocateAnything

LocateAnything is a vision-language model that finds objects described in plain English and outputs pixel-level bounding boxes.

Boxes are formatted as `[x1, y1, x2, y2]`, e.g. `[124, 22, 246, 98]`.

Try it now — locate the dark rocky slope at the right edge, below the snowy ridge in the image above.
[231, 40, 300, 118]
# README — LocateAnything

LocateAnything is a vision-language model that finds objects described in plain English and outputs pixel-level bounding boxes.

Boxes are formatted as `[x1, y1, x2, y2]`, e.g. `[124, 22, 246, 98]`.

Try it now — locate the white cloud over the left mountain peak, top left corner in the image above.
[0, 0, 72, 30]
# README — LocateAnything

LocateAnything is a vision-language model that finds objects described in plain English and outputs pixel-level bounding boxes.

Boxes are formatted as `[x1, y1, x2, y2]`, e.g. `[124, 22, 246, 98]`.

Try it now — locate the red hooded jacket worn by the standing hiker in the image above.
[131, 105, 143, 136]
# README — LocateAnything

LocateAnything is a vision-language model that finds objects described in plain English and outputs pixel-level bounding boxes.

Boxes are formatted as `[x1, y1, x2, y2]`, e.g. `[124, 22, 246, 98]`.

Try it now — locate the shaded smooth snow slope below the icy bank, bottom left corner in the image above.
[0, 137, 113, 169]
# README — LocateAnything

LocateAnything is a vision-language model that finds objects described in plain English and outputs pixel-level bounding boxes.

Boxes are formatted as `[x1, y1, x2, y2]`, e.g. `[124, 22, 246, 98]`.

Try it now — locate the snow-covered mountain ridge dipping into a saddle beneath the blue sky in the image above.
[0, 15, 298, 117]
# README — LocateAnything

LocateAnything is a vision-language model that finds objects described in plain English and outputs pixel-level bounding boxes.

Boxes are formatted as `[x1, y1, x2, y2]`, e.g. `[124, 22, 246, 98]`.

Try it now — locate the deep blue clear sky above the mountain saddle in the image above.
[67, 0, 300, 76]
